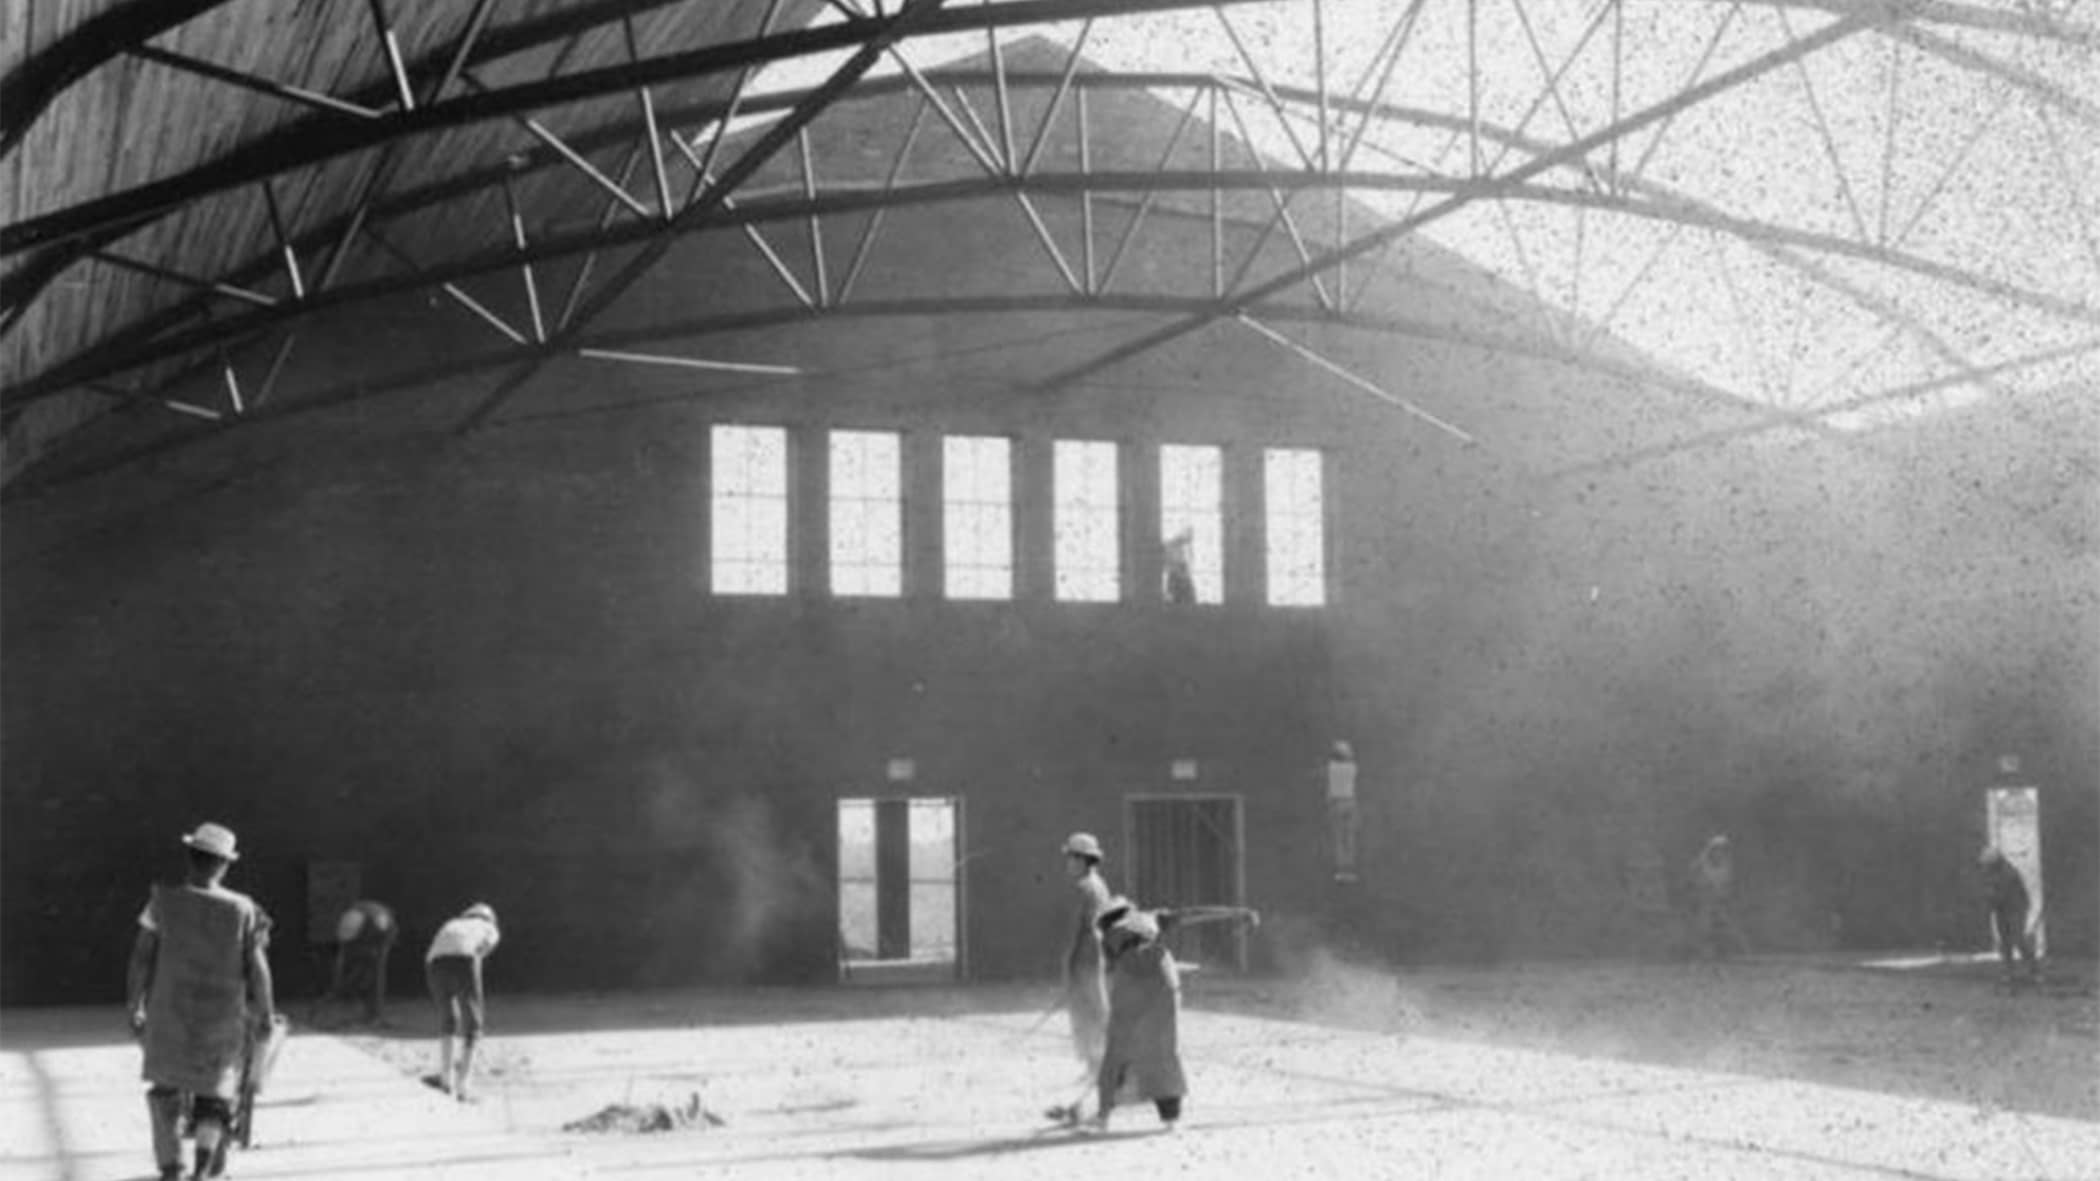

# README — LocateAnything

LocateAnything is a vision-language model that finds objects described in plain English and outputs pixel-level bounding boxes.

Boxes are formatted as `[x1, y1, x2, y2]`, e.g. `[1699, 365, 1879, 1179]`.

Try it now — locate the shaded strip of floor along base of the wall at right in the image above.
[1224, 958, 2100, 1117]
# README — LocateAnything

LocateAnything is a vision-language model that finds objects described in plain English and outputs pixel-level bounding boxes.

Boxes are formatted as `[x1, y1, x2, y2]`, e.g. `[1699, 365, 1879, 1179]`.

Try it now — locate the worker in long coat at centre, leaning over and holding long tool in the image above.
[1092, 899, 1262, 1131]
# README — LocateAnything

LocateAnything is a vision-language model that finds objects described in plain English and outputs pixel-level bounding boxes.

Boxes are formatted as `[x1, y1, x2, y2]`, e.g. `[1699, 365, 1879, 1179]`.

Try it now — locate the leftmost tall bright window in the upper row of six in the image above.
[708, 427, 788, 595]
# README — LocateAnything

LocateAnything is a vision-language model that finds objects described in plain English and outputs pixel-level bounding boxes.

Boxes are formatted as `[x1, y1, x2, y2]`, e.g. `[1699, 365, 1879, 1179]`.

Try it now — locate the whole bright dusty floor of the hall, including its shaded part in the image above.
[0, 949, 2100, 1181]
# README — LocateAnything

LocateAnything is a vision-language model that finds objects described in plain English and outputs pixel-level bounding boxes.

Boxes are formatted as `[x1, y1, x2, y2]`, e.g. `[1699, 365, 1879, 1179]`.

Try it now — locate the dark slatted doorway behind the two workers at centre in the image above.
[1124, 794, 1247, 971]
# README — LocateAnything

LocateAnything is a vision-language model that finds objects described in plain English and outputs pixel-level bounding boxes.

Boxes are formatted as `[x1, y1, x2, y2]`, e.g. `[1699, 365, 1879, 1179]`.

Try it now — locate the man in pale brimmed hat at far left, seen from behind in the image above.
[126, 824, 277, 1181]
